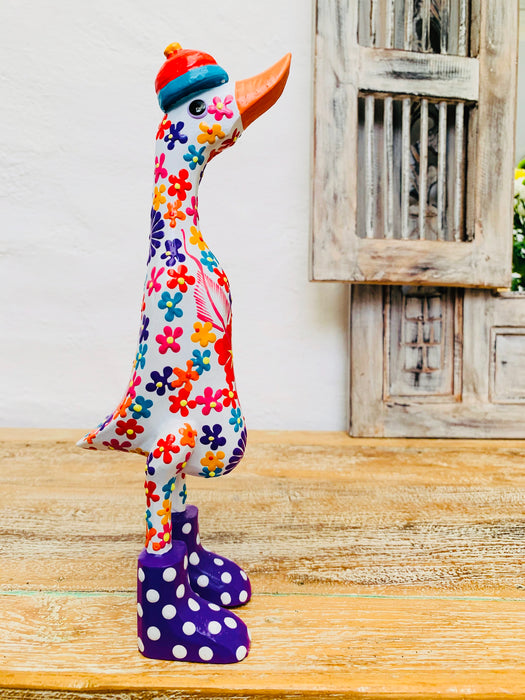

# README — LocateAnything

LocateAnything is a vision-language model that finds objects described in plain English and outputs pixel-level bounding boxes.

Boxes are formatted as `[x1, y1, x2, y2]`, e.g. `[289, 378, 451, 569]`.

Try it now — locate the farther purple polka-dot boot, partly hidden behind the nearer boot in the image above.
[171, 506, 252, 608]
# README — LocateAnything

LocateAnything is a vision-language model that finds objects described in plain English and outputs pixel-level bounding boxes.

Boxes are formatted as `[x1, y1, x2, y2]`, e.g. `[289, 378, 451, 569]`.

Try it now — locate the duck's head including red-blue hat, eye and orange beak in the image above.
[155, 44, 291, 170]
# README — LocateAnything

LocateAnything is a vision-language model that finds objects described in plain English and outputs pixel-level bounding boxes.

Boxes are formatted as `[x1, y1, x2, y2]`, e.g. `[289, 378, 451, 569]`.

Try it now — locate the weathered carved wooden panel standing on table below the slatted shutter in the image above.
[350, 285, 525, 438]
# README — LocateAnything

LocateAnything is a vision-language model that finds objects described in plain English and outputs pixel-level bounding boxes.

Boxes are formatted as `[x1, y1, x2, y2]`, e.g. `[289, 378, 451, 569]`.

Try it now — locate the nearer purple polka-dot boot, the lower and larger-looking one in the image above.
[137, 541, 250, 664]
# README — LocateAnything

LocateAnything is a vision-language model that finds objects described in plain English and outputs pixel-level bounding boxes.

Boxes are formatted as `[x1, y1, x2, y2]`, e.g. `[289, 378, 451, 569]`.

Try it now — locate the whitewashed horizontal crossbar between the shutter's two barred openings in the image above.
[357, 46, 479, 101]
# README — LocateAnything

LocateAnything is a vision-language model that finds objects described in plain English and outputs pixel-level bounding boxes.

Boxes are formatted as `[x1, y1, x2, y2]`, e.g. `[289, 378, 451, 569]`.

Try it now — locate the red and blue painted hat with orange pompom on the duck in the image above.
[155, 44, 228, 112]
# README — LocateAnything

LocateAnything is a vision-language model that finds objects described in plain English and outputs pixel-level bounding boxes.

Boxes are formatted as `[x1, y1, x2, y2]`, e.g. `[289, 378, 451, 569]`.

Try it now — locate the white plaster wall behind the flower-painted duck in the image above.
[0, 0, 348, 430]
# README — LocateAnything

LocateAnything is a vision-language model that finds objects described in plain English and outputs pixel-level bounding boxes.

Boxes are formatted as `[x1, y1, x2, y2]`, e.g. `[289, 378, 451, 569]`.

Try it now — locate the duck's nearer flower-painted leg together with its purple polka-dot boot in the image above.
[137, 435, 250, 663]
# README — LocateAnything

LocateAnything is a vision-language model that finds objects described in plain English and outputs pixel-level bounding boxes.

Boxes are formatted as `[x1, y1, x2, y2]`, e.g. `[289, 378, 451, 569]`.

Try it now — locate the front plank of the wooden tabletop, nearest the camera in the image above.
[0, 593, 525, 698]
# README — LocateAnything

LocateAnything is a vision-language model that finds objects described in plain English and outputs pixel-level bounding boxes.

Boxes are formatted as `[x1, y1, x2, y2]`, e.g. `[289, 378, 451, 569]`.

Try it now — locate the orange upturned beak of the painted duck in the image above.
[235, 54, 292, 129]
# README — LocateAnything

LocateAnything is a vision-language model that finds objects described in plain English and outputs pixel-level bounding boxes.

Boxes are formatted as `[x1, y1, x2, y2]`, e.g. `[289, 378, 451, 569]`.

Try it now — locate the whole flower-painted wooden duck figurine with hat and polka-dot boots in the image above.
[78, 44, 291, 663]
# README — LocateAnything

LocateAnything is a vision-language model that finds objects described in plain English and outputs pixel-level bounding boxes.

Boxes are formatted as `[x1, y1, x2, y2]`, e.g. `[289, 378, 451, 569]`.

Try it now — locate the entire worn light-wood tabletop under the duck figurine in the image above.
[0, 429, 525, 700]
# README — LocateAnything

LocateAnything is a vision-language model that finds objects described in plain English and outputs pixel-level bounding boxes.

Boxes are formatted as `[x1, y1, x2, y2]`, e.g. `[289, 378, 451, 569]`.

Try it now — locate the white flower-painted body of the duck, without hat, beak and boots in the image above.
[82, 79, 246, 552]
